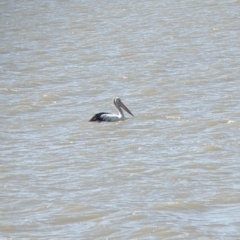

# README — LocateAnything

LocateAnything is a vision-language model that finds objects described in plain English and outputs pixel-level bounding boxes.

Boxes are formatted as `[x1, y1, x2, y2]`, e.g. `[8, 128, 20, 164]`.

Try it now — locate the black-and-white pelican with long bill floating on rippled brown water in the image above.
[89, 97, 133, 122]
